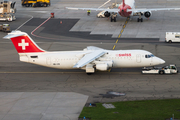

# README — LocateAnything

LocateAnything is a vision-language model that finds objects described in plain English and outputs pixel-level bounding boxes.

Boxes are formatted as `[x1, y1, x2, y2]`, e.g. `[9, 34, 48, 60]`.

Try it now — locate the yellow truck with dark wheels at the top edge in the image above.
[21, 0, 50, 7]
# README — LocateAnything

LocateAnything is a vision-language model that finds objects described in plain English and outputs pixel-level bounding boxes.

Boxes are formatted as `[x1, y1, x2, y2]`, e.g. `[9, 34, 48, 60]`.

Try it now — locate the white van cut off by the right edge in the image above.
[166, 32, 180, 43]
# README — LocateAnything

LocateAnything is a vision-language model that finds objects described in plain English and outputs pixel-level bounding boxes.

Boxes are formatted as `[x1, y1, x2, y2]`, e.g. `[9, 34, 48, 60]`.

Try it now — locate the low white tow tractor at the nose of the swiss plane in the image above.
[142, 64, 178, 75]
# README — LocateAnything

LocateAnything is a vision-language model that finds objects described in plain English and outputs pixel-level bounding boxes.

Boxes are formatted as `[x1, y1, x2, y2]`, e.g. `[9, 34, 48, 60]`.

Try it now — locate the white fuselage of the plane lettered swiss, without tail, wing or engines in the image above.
[19, 50, 163, 69]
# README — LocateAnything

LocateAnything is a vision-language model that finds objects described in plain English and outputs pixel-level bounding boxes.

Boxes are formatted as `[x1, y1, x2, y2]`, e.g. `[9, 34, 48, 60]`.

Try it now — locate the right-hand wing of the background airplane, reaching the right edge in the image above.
[127, 8, 180, 13]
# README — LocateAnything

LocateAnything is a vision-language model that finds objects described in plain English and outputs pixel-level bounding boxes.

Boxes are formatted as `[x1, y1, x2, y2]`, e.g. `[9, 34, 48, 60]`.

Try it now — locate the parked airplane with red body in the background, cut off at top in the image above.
[66, 0, 180, 22]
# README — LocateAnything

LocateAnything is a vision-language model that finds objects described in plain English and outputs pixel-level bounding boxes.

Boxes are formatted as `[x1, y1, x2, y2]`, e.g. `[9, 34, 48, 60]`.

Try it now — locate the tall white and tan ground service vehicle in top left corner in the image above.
[0, 0, 16, 21]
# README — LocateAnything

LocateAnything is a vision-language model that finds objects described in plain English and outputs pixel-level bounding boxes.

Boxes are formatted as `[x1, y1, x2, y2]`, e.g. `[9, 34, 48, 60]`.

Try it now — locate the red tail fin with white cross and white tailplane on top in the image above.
[4, 31, 44, 53]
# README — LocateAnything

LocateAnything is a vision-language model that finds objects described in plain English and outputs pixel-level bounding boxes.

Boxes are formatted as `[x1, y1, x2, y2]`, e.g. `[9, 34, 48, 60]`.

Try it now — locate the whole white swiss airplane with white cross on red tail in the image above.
[3, 30, 165, 74]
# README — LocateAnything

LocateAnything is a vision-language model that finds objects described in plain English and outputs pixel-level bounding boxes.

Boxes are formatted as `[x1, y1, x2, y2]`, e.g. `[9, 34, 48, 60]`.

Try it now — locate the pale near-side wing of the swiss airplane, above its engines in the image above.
[73, 50, 106, 68]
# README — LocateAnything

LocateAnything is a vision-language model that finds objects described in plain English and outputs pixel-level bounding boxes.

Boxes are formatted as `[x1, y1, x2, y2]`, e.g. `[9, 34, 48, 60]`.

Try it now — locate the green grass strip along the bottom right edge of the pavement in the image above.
[79, 99, 180, 120]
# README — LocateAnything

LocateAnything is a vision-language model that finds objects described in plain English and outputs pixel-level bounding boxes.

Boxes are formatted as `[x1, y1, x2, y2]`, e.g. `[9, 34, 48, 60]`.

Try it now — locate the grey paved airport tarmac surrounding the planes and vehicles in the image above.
[0, 0, 180, 120]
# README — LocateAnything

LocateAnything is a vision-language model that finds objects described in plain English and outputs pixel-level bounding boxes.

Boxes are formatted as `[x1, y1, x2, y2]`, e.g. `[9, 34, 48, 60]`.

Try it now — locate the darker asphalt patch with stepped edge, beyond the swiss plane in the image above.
[20, 18, 159, 43]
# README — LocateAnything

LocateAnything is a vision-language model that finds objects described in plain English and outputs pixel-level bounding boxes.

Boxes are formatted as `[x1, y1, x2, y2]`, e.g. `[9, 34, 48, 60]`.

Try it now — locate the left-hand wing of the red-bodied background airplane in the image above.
[66, 7, 119, 13]
